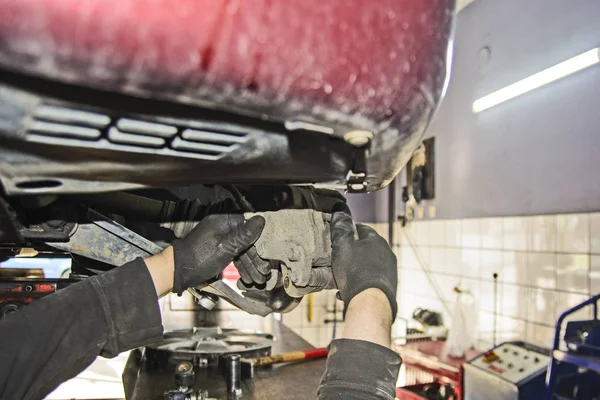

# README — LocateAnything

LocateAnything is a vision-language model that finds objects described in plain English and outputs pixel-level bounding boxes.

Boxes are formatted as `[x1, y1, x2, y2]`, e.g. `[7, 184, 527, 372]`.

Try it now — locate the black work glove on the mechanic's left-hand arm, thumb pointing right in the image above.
[173, 214, 265, 294]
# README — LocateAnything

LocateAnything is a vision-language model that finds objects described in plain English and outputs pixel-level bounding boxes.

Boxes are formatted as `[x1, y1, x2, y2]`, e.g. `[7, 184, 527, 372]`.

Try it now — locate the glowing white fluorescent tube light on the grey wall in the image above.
[473, 47, 600, 113]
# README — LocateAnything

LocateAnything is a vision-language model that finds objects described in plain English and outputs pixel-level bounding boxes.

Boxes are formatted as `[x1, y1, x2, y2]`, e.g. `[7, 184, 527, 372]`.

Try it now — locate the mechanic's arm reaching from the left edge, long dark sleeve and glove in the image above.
[0, 214, 264, 400]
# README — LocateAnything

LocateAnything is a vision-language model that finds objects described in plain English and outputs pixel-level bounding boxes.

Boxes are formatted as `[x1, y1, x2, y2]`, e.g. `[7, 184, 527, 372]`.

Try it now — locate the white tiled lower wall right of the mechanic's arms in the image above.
[398, 213, 600, 347]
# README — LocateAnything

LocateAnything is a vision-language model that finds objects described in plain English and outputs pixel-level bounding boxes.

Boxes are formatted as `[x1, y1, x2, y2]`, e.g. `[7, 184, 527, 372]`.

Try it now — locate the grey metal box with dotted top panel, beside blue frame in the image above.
[463, 341, 550, 400]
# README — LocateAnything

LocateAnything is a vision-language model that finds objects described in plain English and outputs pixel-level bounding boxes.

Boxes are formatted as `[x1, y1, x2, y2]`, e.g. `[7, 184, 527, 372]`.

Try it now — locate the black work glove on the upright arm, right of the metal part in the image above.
[331, 204, 398, 320]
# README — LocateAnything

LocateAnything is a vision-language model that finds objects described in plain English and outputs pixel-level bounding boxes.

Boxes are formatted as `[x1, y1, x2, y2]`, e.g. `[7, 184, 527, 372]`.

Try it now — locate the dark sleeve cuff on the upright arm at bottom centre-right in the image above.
[318, 339, 402, 400]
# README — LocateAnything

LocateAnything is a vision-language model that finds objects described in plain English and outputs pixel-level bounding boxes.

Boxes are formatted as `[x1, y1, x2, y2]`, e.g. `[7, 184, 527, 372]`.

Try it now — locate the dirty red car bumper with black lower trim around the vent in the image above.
[0, 0, 455, 194]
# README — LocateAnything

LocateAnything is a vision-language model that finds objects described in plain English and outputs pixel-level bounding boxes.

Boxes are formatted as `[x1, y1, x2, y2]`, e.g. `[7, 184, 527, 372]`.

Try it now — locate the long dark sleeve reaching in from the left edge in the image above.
[0, 259, 163, 400]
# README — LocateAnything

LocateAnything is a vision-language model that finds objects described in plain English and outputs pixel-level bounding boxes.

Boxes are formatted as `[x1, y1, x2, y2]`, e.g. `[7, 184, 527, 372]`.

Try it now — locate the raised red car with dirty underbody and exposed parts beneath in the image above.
[0, 0, 455, 315]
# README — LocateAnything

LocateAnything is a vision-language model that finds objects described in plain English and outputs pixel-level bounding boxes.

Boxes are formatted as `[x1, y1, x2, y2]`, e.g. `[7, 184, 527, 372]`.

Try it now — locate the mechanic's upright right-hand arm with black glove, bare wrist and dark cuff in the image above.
[318, 205, 402, 400]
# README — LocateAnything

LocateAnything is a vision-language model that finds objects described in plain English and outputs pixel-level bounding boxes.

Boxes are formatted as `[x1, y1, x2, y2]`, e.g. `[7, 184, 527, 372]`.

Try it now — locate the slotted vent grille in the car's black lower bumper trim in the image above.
[25, 104, 251, 160]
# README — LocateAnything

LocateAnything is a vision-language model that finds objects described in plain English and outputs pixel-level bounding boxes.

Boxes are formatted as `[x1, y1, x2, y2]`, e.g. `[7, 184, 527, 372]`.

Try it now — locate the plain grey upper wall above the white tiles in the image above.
[420, 0, 600, 218]
